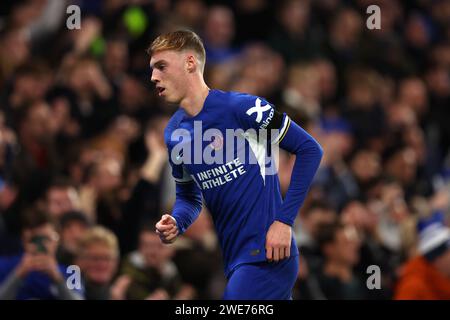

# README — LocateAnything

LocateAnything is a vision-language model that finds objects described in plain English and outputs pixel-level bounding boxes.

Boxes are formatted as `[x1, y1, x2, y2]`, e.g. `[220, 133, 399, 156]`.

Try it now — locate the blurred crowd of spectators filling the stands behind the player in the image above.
[0, 0, 450, 299]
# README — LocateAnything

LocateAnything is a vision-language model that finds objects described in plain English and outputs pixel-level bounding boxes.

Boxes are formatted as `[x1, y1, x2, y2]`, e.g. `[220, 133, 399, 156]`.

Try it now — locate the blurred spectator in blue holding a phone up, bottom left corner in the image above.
[0, 211, 81, 300]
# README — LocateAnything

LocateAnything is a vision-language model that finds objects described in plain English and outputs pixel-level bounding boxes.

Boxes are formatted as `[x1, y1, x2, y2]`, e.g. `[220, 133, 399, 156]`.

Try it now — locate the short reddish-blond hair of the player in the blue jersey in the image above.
[147, 30, 206, 71]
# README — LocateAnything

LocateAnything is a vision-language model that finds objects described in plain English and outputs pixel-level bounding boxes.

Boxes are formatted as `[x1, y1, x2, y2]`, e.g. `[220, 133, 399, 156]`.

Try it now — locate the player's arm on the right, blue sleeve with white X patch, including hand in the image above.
[233, 95, 323, 261]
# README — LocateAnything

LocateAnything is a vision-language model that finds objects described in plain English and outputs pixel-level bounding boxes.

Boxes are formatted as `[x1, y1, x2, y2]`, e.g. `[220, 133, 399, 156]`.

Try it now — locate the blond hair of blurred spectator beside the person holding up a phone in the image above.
[78, 226, 119, 258]
